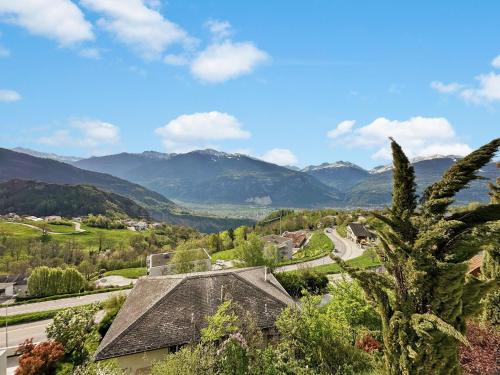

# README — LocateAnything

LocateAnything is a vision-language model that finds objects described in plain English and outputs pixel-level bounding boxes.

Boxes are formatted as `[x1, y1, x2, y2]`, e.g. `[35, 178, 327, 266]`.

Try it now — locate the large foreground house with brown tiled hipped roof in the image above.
[95, 267, 295, 375]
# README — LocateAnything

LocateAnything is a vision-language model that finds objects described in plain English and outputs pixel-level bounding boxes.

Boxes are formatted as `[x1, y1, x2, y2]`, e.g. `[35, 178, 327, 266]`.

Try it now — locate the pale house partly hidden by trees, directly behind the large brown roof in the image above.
[146, 249, 212, 276]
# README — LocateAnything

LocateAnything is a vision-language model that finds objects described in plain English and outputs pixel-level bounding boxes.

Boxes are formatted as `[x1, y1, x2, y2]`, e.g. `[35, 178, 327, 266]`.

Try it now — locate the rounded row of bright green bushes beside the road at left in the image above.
[28, 266, 86, 297]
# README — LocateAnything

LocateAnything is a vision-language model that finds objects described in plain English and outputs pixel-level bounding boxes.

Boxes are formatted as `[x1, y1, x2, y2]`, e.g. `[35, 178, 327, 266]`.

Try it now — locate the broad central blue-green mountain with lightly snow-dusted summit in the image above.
[75, 150, 341, 207]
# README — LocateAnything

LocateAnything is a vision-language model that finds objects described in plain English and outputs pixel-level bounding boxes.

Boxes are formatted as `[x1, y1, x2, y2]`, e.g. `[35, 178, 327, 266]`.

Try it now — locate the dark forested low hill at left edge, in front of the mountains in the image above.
[0, 180, 149, 218]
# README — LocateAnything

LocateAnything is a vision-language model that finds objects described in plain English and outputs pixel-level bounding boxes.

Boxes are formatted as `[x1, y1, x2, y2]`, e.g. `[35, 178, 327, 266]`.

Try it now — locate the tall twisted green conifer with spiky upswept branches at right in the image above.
[334, 139, 500, 375]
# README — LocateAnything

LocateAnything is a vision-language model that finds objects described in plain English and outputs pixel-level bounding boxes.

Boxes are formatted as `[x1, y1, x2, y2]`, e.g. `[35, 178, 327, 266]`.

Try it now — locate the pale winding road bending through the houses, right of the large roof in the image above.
[275, 228, 364, 272]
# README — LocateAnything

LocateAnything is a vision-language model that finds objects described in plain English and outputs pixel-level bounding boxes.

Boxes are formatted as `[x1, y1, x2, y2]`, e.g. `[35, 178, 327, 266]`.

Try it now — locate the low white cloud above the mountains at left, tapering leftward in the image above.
[38, 119, 120, 154]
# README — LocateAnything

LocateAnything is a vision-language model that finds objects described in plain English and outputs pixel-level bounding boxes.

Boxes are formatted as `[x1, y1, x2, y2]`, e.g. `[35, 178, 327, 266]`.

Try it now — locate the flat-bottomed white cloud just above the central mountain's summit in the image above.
[155, 111, 250, 152]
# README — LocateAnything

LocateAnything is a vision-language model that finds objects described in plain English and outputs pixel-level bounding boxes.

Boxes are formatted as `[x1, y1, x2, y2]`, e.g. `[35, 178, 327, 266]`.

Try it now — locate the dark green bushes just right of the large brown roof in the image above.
[275, 268, 328, 298]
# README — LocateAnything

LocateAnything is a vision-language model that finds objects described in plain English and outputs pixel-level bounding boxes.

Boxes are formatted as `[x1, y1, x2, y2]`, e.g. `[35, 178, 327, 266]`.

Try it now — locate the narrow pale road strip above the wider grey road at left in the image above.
[2, 289, 131, 316]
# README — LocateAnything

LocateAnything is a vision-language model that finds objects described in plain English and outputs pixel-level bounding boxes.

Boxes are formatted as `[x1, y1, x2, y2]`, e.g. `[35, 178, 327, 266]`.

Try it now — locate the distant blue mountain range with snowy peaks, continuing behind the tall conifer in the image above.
[6, 149, 498, 212]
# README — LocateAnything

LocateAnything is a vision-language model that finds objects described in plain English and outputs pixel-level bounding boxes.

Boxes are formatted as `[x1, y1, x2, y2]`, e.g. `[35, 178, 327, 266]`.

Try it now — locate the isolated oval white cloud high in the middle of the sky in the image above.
[191, 40, 269, 83]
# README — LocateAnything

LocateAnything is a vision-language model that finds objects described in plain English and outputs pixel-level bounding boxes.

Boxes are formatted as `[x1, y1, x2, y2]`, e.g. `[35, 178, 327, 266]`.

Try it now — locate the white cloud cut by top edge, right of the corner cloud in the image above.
[81, 0, 194, 59]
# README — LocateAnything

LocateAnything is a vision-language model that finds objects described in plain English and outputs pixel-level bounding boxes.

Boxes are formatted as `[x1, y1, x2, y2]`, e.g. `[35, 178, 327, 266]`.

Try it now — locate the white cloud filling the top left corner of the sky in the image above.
[0, 0, 94, 46]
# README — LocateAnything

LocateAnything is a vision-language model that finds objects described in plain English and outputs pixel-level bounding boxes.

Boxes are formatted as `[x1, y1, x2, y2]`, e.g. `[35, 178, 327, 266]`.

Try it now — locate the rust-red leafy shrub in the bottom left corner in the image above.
[15, 339, 64, 375]
